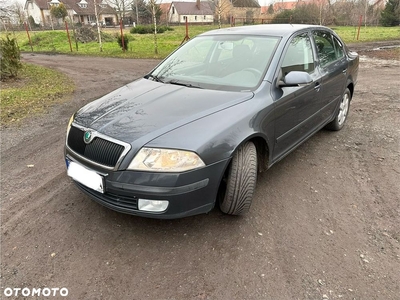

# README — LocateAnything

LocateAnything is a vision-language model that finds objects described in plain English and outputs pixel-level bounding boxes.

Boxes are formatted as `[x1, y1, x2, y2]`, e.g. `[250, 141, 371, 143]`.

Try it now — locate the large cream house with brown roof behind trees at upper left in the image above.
[24, 0, 117, 26]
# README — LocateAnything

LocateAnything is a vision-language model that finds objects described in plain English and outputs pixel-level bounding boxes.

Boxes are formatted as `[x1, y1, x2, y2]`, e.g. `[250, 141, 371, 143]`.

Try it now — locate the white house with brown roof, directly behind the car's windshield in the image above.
[168, 0, 214, 24]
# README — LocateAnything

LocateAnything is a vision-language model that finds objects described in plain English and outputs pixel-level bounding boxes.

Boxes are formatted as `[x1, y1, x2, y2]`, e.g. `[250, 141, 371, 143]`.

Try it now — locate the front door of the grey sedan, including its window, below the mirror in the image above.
[273, 33, 322, 160]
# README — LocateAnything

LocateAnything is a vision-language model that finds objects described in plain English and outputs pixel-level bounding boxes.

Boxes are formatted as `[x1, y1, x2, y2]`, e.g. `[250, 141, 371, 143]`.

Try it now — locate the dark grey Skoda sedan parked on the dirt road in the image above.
[65, 24, 359, 218]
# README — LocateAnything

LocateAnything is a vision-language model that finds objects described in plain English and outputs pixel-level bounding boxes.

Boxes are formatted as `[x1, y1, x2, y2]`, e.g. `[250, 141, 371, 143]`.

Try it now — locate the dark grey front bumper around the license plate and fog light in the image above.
[66, 155, 229, 219]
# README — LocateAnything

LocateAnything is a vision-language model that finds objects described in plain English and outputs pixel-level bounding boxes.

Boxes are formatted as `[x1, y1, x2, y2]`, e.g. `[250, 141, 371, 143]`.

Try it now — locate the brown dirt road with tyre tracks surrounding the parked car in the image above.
[0, 44, 400, 300]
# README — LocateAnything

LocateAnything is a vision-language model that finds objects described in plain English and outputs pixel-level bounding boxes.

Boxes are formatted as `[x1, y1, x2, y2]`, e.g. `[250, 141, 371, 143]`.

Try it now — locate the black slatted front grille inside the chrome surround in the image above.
[67, 126, 125, 167]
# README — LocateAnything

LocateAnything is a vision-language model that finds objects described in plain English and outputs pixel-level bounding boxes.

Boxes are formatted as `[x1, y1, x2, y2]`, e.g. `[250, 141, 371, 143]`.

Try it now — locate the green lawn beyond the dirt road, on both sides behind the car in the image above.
[0, 25, 400, 59]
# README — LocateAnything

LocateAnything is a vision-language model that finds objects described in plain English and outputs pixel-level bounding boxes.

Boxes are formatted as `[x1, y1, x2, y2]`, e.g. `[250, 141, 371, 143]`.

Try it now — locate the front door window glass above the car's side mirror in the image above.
[282, 33, 314, 76]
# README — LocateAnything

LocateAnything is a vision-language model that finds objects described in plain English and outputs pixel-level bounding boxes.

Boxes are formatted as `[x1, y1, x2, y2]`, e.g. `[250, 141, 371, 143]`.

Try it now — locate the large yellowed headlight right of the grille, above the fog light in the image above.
[128, 148, 205, 172]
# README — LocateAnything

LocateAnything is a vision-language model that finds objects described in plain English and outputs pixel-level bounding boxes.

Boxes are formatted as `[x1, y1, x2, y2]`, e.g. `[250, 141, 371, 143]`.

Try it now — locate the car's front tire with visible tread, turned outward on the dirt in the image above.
[219, 142, 257, 215]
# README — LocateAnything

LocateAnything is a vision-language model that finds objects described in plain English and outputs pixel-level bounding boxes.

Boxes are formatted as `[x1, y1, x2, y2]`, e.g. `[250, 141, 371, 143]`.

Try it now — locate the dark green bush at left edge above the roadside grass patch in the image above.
[0, 35, 22, 80]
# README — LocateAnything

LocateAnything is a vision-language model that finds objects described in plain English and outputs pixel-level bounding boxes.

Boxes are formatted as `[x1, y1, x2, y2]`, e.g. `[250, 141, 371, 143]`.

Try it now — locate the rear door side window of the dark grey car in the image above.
[313, 31, 343, 67]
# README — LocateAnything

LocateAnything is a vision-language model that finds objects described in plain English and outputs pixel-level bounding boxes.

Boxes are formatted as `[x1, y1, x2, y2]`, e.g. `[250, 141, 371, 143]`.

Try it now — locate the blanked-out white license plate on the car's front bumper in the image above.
[67, 161, 104, 193]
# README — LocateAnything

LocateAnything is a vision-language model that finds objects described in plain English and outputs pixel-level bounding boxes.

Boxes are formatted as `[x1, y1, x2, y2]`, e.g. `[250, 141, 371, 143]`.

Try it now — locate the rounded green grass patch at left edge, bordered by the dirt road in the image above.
[0, 64, 74, 125]
